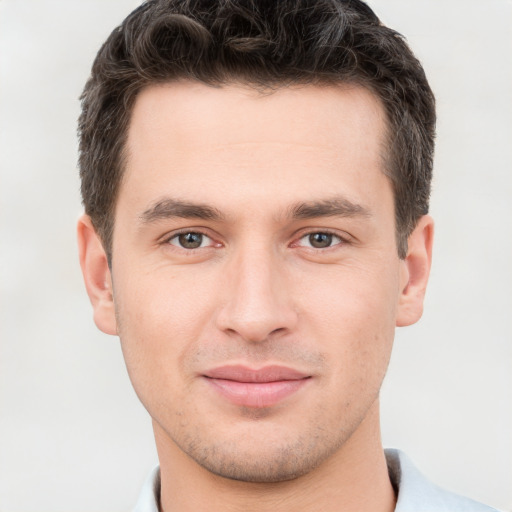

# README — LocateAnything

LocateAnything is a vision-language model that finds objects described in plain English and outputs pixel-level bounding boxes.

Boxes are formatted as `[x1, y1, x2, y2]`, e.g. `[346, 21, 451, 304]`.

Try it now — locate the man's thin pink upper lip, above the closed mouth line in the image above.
[204, 365, 310, 383]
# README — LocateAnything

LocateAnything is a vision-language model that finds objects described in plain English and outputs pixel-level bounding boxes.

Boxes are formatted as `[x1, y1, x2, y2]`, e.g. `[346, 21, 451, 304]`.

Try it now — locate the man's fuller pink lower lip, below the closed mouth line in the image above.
[206, 378, 309, 408]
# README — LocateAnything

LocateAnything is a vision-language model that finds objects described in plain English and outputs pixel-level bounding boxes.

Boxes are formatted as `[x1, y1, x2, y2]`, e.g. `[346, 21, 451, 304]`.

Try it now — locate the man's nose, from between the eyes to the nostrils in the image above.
[217, 248, 297, 342]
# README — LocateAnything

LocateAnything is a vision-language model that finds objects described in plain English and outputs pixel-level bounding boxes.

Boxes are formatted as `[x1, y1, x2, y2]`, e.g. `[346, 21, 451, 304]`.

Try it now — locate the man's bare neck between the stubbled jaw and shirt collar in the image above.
[154, 402, 395, 512]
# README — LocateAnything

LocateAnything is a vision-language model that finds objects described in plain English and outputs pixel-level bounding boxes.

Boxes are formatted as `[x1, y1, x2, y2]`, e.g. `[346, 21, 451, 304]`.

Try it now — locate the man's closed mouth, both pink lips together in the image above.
[203, 365, 311, 408]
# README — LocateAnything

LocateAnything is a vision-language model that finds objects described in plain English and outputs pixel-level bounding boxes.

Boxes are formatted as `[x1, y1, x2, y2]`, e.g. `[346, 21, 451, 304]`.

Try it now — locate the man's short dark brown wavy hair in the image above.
[79, 0, 435, 259]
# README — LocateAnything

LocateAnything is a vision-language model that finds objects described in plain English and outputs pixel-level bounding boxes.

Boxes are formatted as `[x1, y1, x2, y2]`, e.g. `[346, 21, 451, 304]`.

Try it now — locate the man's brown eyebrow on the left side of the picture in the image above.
[140, 198, 224, 224]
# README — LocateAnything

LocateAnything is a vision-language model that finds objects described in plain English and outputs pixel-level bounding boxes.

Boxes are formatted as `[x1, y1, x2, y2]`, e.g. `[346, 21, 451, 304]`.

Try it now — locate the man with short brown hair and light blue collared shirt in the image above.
[78, 0, 498, 512]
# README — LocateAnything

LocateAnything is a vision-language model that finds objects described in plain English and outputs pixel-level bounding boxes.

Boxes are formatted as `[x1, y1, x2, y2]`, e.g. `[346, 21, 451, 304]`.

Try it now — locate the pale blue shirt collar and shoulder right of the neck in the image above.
[386, 450, 498, 512]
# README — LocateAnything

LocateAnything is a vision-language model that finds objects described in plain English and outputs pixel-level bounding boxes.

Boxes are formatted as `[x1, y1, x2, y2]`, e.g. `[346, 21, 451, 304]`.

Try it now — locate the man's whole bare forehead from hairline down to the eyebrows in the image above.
[120, 82, 392, 216]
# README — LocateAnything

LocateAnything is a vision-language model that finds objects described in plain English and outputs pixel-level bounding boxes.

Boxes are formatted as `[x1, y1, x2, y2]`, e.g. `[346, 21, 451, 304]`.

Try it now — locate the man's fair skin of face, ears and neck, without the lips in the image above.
[78, 82, 433, 512]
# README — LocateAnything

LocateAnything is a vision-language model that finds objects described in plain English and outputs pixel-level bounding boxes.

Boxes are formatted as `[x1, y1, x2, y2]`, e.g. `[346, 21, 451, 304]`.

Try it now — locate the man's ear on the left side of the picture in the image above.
[77, 215, 117, 334]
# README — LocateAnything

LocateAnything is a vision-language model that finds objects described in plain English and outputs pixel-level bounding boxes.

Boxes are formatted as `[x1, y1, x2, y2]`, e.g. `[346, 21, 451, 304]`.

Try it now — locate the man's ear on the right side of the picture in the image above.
[396, 215, 434, 327]
